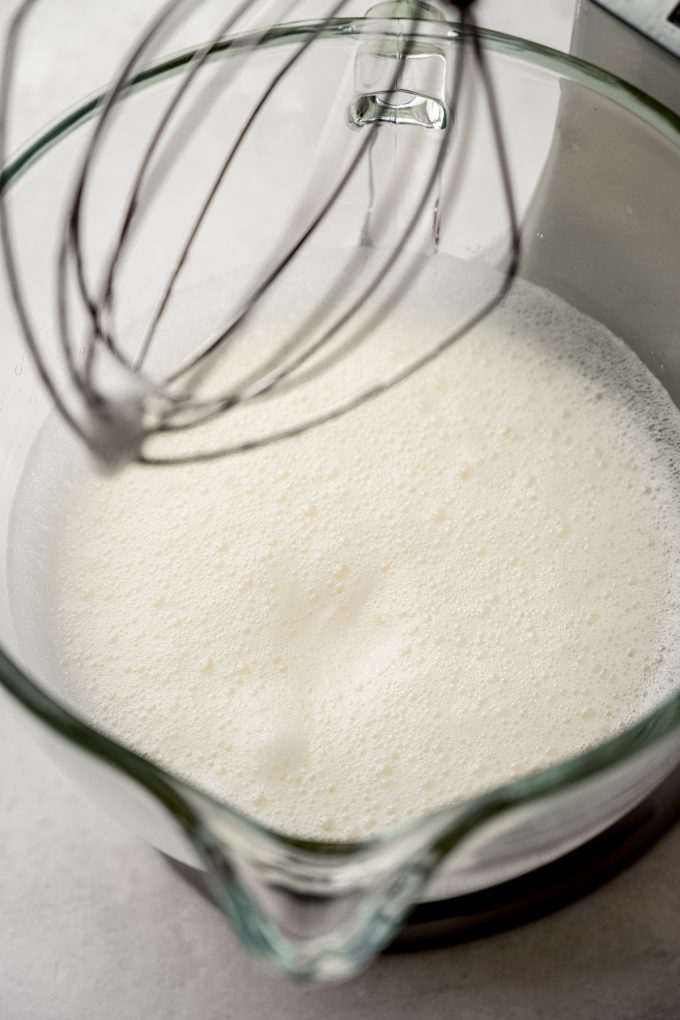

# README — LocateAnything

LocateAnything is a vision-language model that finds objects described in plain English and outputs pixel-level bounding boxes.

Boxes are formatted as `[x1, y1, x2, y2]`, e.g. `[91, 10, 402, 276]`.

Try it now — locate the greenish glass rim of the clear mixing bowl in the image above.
[0, 17, 680, 855]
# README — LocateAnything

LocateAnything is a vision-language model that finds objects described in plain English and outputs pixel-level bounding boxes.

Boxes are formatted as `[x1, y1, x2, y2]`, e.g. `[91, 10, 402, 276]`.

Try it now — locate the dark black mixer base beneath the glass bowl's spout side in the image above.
[158, 769, 680, 953]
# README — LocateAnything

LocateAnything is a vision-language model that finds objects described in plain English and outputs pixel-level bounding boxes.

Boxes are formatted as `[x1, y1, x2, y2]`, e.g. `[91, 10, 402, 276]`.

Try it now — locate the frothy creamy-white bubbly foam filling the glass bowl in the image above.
[12, 250, 680, 838]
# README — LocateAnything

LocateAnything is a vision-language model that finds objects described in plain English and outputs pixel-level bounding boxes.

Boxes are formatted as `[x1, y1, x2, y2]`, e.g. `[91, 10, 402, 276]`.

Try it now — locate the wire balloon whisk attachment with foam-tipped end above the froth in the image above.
[0, 0, 520, 465]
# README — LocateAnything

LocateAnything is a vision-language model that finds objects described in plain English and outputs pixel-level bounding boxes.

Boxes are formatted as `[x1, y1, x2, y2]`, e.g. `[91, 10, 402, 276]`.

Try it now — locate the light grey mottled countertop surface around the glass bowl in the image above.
[0, 0, 680, 1020]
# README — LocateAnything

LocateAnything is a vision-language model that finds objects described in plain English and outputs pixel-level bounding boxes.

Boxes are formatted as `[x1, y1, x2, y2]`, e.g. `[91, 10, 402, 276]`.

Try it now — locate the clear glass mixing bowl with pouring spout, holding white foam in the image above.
[0, 19, 680, 981]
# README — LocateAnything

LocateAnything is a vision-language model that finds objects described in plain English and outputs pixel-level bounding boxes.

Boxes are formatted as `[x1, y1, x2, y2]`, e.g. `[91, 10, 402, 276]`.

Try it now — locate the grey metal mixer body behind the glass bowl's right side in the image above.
[522, 0, 680, 403]
